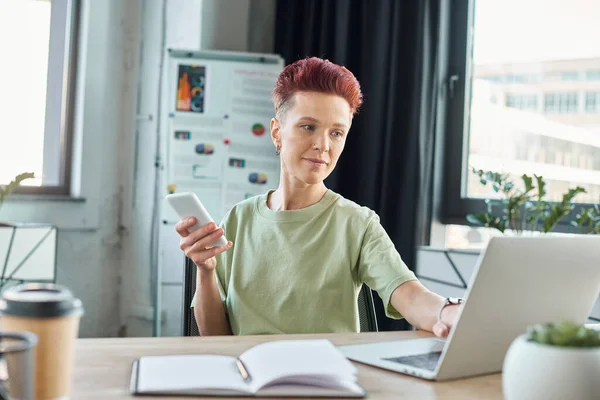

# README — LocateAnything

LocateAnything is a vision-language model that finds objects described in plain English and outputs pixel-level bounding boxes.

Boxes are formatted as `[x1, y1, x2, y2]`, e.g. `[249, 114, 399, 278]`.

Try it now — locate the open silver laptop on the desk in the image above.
[339, 235, 600, 381]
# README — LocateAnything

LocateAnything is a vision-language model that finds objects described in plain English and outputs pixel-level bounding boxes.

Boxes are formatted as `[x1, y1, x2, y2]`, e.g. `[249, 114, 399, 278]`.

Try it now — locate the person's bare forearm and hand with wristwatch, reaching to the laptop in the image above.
[391, 280, 459, 337]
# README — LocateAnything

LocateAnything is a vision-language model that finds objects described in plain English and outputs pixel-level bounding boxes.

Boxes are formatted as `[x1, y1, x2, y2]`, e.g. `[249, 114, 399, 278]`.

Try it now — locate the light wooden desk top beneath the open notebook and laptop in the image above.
[70, 332, 502, 400]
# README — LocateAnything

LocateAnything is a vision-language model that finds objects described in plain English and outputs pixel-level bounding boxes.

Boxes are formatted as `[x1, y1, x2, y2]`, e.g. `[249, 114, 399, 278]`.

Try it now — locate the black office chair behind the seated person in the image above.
[183, 257, 377, 336]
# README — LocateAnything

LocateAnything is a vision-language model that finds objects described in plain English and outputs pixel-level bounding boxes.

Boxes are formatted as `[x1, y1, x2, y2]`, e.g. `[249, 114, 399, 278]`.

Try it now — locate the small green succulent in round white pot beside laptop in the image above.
[502, 321, 600, 400]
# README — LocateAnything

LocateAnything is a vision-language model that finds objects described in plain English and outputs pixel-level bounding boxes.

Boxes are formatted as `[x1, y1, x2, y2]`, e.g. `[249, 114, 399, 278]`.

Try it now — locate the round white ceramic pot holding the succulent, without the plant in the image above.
[502, 335, 600, 400]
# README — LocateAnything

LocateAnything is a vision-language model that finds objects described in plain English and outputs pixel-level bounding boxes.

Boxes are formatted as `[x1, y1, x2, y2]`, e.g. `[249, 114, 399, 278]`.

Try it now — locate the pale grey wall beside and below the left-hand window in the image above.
[0, 0, 140, 337]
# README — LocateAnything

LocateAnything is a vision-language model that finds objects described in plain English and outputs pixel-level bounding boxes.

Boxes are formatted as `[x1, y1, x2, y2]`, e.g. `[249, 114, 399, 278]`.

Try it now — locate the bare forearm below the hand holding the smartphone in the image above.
[194, 268, 232, 336]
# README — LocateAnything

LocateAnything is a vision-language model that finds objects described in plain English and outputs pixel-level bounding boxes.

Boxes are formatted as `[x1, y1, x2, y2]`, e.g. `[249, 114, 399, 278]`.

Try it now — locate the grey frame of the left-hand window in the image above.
[6, 0, 81, 197]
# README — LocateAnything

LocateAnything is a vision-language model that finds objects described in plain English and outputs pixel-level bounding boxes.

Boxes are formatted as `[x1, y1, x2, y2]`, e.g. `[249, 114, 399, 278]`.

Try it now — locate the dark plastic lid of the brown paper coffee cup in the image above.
[0, 283, 83, 318]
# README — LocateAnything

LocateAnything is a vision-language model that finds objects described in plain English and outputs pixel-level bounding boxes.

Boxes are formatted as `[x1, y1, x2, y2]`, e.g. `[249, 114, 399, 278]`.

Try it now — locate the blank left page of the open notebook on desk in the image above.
[137, 355, 249, 394]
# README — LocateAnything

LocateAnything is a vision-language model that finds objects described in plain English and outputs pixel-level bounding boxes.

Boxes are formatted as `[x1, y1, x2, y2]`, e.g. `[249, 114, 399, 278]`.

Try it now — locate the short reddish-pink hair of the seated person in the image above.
[273, 57, 363, 115]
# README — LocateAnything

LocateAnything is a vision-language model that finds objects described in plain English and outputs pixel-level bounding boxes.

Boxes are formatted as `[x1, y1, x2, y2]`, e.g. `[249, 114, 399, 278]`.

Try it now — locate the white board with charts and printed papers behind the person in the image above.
[163, 51, 283, 221]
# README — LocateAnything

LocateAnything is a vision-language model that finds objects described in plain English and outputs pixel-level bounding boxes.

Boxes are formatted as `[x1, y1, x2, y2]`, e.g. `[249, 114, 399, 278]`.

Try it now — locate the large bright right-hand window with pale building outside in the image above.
[437, 0, 600, 247]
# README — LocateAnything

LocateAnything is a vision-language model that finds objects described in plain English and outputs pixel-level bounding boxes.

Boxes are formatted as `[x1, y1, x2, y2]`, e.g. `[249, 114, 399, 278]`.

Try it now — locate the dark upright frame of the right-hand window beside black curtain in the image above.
[437, 0, 592, 233]
